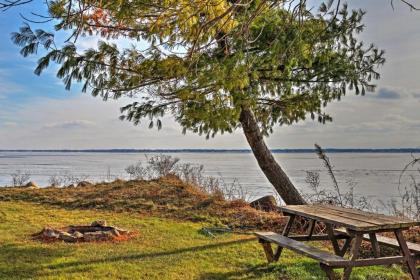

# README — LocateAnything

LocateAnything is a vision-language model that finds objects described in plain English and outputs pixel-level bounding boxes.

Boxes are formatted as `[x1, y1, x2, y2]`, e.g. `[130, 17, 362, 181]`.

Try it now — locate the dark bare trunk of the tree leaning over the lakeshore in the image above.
[239, 108, 306, 204]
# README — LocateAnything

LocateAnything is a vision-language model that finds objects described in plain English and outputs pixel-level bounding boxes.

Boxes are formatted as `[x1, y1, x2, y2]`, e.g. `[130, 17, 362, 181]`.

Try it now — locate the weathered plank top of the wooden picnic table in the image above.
[280, 204, 420, 232]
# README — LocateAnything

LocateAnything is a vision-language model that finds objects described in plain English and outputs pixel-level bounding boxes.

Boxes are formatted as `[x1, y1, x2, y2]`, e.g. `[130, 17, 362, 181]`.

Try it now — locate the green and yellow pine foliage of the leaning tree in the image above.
[13, 0, 384, 137]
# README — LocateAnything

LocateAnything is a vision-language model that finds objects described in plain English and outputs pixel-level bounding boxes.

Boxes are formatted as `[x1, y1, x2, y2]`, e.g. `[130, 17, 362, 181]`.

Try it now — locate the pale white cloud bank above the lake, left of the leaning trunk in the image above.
[0, 95, 247, 149]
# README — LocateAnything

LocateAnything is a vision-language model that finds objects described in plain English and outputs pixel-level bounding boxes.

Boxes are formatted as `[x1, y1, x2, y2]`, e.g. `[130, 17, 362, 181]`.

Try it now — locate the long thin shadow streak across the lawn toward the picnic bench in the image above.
[47, 238, 255, 269]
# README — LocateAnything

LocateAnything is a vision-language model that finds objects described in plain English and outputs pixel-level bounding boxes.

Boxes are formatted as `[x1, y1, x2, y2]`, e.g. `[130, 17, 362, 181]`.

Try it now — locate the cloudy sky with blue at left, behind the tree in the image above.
[0, 0, 420, 149]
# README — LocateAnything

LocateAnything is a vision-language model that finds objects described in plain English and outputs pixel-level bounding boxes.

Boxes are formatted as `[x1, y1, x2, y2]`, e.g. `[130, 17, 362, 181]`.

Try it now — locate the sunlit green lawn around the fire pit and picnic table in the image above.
[0, 201, 409, 280]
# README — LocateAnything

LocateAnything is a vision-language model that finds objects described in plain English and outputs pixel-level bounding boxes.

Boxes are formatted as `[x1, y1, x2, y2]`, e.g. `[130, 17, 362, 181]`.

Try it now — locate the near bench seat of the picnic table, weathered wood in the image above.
[255, 232, 349, 267]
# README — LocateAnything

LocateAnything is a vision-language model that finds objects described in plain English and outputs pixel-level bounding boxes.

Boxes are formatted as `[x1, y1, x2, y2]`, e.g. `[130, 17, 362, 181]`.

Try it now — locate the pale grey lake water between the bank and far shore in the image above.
[0, 151, 415, 208]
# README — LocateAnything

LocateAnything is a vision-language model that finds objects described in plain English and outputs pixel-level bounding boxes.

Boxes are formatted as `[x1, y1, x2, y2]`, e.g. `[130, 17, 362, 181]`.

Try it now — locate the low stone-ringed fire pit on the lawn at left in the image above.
[33, 220, 133, 243]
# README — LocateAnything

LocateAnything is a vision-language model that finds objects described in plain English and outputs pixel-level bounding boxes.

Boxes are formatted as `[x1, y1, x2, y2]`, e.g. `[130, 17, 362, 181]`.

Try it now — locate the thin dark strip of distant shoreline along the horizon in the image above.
[0, 148, 420, 154]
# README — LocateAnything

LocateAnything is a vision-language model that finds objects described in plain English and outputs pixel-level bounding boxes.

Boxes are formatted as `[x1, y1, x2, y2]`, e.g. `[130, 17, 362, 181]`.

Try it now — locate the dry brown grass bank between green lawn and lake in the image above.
[0, 176, 285, 230]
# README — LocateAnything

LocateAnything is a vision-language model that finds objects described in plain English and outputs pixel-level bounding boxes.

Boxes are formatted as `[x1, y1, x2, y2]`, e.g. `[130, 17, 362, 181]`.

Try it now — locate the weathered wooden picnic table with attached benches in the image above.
[255, 205, 420, 280]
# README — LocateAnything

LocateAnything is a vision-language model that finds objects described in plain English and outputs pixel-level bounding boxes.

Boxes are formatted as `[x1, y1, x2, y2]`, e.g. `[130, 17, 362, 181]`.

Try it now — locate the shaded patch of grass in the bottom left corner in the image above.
[0, 244, 72, 279]
